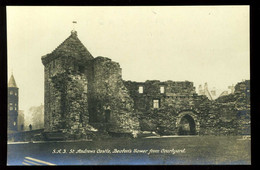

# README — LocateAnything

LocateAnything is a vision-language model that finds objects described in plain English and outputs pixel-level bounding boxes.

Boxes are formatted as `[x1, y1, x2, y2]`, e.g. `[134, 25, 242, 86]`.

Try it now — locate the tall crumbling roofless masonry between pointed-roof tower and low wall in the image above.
[91, 57, 139, 133]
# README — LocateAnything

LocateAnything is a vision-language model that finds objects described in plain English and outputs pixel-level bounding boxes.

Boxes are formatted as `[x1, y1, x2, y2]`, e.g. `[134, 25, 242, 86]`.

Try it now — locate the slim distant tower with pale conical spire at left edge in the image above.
[7, 74, 19, 131]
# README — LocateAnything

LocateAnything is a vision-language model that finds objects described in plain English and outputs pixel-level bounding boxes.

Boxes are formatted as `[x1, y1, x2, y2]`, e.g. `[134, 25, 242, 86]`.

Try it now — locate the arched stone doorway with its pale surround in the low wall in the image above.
[176, 111, 200, 135]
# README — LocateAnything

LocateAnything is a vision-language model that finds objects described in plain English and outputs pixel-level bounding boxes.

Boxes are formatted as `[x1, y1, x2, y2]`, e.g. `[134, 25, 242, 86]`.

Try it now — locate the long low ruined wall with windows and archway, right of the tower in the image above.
[124, 81, 250, 135]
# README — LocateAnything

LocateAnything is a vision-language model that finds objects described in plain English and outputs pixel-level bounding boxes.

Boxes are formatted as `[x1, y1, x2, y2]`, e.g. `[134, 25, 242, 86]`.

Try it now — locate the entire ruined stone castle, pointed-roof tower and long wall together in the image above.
[42, 31, 250, 137]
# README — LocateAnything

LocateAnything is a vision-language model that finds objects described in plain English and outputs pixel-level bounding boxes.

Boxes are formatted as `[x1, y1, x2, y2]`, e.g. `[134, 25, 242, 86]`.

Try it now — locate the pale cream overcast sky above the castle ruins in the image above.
[7, 6, 250, 116]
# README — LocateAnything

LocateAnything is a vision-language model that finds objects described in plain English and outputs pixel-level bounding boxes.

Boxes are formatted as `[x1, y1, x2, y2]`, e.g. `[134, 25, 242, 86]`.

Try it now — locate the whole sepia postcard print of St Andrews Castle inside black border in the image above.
[7, 6, 251, 165]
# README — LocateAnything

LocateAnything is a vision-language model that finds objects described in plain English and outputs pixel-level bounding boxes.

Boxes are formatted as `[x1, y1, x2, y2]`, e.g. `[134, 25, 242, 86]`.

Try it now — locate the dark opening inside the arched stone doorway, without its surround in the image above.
[178, 114, 196, 135]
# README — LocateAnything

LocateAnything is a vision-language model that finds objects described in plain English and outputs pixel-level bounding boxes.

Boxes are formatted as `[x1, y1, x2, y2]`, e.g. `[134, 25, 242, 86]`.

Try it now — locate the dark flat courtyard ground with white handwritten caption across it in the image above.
[7, 136, 251, 165]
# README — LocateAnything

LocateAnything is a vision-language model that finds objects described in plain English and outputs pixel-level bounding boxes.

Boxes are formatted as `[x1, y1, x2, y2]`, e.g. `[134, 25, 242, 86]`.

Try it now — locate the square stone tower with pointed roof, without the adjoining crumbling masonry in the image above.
[42, 31, 93, 131]
